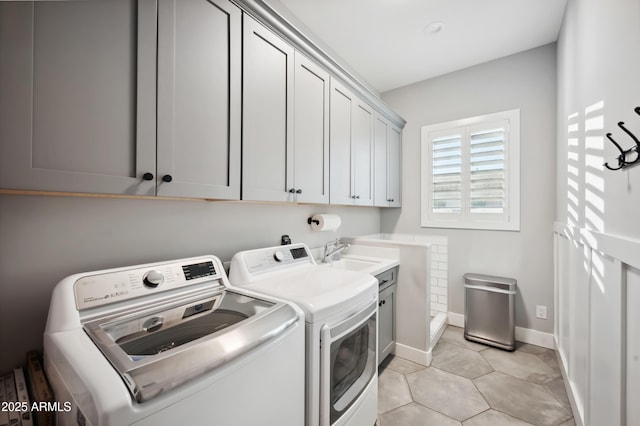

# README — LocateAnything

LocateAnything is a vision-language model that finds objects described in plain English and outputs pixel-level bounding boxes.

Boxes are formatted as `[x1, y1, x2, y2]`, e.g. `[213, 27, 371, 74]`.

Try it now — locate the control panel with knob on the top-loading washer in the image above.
[74, 257, 223, 310]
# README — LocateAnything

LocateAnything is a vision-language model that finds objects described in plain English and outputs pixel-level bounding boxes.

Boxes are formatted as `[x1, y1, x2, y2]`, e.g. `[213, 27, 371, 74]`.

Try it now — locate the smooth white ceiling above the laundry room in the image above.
[266, 0, 566, 92]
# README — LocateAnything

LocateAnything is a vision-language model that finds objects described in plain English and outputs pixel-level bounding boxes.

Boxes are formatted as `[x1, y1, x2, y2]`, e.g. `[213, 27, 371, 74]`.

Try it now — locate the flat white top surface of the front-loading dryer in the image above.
[232, 265, 378, 323]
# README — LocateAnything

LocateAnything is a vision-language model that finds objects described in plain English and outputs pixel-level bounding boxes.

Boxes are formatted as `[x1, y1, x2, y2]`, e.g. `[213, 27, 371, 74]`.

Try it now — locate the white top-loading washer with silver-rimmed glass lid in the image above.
[44, 256, 305, 426]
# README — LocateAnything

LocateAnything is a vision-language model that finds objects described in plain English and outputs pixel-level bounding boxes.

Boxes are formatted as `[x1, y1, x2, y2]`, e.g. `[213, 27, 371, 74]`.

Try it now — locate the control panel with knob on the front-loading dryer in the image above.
[244, 245, 315, 274]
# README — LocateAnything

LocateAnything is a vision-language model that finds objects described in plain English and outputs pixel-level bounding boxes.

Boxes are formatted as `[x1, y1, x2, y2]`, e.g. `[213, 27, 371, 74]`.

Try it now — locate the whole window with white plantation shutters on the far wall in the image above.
[421, 110, 520, 230]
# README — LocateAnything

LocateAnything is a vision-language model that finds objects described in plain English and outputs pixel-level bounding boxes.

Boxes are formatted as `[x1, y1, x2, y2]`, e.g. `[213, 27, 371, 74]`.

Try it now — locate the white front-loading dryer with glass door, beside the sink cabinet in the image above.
[229, 244, 378, 426]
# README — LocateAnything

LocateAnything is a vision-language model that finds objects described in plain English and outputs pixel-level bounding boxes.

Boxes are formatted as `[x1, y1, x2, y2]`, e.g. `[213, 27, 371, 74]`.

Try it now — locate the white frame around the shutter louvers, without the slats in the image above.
[420, 109, 520, 231]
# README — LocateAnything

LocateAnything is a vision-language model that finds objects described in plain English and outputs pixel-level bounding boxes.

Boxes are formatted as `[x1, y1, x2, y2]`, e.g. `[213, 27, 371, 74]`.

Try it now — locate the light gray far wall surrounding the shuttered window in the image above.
[382, 44, 556, 332]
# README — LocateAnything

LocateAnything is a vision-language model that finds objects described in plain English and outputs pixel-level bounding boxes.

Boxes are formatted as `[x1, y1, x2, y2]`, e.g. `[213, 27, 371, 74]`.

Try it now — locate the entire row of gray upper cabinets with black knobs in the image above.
[0, 0, 401, 206]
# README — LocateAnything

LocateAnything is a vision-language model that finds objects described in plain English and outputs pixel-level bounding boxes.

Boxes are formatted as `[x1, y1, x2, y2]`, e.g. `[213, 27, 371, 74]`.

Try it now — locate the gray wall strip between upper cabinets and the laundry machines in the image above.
[0, 195, 380, 372]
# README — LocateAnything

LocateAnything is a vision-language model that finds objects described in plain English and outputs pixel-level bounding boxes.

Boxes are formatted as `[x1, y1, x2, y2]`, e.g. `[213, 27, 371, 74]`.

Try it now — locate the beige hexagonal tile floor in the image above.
[377, 326, 575, 426]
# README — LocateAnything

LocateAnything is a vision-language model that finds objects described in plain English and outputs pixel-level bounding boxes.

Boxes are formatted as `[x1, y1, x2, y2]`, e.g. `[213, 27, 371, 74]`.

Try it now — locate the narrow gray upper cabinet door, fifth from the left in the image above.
[329, 79, 355, 204]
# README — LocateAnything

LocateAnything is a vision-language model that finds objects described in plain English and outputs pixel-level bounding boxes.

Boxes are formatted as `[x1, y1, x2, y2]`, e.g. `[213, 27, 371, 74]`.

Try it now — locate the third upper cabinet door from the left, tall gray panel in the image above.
[242, 15, 295, 201]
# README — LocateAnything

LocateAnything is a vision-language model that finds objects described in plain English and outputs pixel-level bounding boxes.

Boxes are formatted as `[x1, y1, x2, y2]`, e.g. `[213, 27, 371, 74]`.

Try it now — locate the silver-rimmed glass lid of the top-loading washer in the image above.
[84, 290, 299, 402]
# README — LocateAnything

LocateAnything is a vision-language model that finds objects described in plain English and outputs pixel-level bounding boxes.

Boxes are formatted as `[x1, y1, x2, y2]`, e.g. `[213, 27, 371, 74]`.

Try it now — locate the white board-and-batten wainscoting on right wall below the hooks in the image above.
[553, 222, 640, 425]
